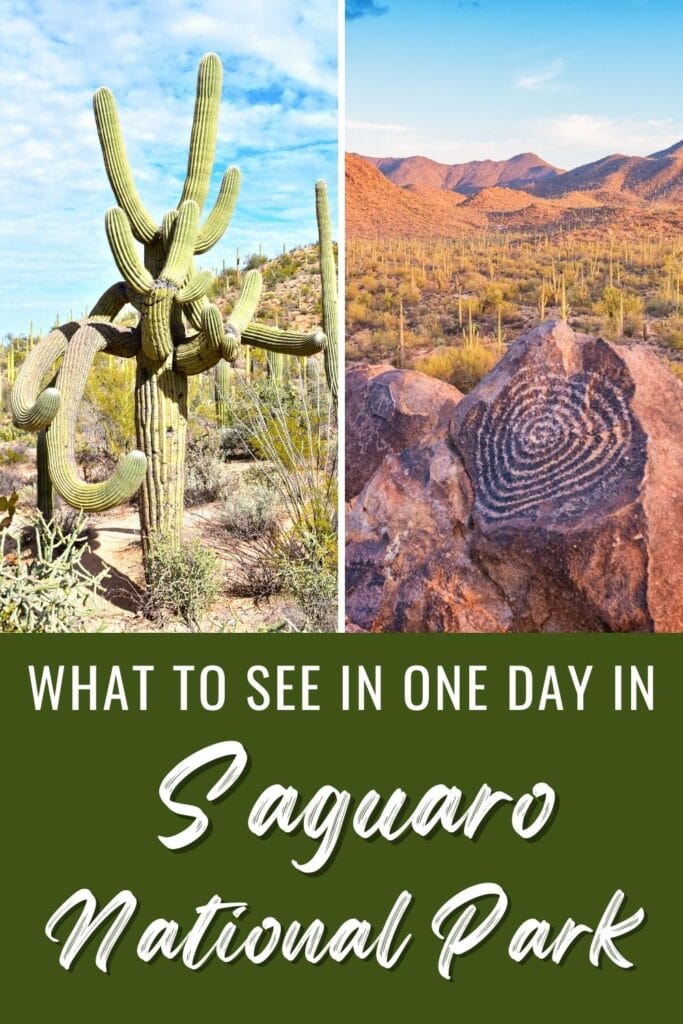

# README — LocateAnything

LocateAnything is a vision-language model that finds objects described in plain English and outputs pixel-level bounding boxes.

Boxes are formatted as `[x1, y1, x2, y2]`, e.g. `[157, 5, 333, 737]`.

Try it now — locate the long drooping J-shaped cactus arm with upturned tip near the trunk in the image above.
[47, 324, 146, 512]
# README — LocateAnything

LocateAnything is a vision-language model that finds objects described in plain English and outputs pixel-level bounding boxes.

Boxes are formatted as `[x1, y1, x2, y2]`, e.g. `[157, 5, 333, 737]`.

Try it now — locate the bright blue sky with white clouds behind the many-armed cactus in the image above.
[0, 0, 337, 336]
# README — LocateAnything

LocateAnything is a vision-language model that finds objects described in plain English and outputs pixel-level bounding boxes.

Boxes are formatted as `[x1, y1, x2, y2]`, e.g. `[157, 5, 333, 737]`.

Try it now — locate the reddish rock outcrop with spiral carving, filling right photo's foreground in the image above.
[347, 324, 683, 632]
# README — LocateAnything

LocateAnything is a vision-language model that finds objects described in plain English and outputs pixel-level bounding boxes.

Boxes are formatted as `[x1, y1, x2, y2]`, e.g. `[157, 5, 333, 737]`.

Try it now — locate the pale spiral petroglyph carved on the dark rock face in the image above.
[474, 371, 642, 523]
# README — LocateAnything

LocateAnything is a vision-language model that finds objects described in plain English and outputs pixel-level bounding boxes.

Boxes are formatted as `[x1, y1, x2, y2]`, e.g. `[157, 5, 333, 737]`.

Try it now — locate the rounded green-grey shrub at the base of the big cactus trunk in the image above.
[143, 535, 220, 631]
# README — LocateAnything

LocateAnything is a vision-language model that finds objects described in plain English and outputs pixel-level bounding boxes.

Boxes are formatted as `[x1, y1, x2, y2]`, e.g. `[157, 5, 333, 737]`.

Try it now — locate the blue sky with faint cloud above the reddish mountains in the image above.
[346, 0, 683, 168]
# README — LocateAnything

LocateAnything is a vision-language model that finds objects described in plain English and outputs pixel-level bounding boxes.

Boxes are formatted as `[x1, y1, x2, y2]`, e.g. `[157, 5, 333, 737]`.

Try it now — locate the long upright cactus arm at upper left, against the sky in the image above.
[92, 88, 159, 243]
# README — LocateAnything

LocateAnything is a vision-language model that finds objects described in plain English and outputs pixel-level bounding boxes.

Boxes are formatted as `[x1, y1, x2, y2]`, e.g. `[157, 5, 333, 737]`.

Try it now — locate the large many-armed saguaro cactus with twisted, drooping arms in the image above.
[12, 53, 326, 560]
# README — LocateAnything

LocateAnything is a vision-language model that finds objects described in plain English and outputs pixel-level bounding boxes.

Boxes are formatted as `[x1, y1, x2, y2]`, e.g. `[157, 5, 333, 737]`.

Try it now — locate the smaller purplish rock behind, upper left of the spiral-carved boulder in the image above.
[345, 366, 462, 500]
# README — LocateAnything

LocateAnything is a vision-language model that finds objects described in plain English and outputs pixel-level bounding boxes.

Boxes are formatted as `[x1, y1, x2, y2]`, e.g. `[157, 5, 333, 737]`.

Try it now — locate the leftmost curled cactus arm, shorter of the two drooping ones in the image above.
[10, 324, 79, 430]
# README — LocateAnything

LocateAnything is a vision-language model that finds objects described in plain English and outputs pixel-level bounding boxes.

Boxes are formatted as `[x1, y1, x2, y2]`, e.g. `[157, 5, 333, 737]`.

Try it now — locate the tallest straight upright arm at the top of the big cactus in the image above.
[180, 53, 223, 210]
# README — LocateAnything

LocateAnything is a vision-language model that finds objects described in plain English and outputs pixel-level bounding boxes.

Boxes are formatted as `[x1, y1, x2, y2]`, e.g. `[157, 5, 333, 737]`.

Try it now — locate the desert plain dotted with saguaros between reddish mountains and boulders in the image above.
[346, 226, 683, 392]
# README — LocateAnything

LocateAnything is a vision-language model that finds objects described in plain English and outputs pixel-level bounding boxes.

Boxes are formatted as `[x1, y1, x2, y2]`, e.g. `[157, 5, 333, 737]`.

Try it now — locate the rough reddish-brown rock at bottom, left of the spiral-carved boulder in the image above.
[346, 440, 512, 633]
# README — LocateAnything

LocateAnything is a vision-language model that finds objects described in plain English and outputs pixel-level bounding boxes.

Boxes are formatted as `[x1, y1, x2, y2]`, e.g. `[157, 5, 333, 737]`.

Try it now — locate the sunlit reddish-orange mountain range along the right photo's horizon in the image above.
[346, 141, 683, 238]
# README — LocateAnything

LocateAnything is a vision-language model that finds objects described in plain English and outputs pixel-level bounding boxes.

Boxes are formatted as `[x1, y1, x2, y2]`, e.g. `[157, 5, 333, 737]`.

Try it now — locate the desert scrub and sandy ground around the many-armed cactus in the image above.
[0, 246, 337, 632]
